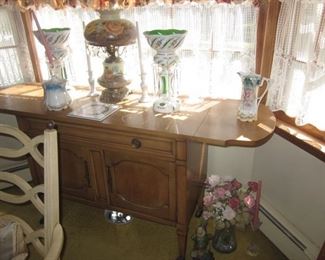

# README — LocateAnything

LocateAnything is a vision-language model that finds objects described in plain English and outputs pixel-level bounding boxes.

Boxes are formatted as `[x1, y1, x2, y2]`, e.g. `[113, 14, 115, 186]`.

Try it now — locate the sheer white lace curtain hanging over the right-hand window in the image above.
[267, 0, 325, 130]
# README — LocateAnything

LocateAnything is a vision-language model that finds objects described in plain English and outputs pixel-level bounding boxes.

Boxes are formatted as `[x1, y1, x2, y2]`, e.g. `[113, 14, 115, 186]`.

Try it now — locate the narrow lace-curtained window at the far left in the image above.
[0, 7, 34, 87]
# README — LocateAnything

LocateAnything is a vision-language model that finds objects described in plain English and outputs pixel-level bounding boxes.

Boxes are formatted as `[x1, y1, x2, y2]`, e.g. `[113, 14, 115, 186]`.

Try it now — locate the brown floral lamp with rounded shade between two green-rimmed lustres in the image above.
[84, 9, 137, 103]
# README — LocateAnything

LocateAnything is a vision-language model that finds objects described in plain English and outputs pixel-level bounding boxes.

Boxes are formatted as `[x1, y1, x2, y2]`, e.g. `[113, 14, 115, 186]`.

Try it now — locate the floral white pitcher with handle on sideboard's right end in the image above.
[237, 72, 269, 122]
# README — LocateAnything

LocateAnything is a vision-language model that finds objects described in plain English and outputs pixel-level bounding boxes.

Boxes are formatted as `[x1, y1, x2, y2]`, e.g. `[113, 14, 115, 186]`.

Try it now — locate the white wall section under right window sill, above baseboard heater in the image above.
[253, 135, 325, 256]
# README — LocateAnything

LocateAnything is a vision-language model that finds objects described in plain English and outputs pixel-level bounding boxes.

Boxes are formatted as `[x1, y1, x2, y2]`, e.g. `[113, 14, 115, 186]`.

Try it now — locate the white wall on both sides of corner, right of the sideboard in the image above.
[208, 134, 325, 258]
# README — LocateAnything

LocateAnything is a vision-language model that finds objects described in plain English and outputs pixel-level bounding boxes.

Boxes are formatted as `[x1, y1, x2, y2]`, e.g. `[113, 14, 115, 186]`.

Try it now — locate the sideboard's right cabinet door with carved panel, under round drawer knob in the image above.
[105, 152, 176, 220]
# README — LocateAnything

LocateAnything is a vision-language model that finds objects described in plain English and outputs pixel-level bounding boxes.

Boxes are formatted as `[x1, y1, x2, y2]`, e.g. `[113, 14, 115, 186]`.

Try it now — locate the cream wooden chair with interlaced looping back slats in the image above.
[0, 124, 64, 260]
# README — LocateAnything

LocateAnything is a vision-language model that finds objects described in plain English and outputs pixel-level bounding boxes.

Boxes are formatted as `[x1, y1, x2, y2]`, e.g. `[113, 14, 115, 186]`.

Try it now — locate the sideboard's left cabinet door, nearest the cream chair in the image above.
[59, 140, 106, 204]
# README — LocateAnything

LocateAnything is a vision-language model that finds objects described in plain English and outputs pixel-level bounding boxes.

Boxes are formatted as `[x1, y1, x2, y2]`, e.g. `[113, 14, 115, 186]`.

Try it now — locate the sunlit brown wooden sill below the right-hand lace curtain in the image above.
[275, 119, 325, 162]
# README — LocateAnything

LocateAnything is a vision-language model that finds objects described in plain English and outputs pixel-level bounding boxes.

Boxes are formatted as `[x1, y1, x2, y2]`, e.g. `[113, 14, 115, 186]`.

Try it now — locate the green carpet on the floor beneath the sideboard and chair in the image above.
[0, 200, 287, 260]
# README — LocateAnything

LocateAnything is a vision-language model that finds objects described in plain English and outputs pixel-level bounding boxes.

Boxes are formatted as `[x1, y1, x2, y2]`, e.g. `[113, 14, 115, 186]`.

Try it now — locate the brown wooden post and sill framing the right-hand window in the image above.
[256, 0, 325, 162]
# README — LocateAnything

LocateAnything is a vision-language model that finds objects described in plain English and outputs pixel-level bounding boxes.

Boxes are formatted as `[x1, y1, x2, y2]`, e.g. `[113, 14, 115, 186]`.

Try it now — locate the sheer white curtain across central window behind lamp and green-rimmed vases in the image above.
[31, 1, 258, 98]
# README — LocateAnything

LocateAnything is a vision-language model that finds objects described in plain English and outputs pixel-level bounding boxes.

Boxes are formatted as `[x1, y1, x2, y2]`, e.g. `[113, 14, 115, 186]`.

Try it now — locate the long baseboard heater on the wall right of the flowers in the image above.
[260, 200, 320, 260]
